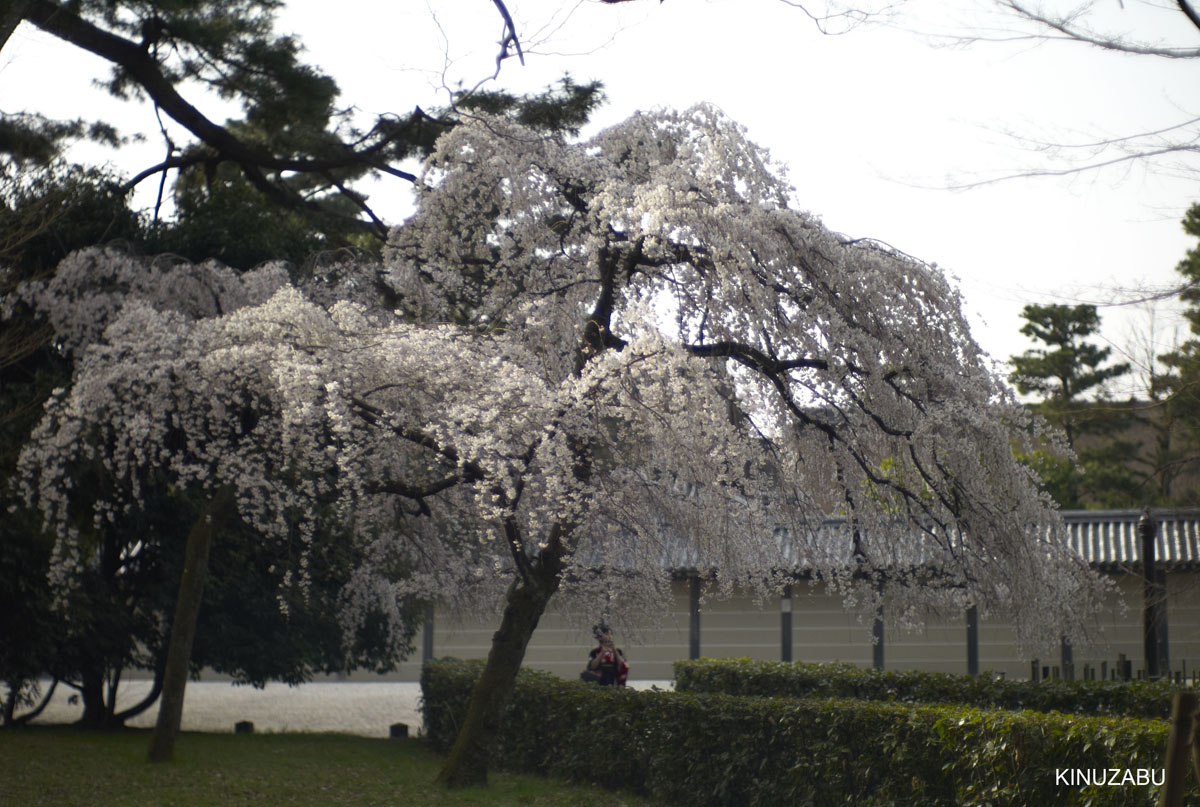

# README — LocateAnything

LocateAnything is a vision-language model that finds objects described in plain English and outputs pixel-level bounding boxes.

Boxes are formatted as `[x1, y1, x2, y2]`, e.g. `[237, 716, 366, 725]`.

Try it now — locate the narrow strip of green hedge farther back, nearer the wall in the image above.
[674, 658, 1180, 719]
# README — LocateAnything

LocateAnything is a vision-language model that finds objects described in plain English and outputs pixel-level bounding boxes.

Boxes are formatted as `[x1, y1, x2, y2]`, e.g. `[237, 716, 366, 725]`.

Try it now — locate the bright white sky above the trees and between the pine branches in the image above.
[0, 0, 1200, 393]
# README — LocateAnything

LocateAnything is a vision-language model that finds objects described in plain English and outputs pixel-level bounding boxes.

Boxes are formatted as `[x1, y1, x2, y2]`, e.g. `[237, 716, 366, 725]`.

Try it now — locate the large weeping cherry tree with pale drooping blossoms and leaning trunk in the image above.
[18, 107, 1102, 784]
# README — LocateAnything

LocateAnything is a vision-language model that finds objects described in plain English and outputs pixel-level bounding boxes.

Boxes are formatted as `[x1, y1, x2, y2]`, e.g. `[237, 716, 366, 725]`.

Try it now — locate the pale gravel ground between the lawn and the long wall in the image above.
[25, 681, 671, 737]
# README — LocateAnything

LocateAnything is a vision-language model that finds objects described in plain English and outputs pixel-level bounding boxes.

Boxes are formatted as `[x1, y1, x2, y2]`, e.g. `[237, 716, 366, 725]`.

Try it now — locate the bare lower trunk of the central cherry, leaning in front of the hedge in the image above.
[436, 542, 564, 788]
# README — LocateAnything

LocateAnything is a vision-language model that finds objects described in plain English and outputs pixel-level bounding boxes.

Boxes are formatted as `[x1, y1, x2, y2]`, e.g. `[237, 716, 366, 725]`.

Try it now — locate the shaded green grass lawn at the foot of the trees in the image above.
[0, 728, 654, 807]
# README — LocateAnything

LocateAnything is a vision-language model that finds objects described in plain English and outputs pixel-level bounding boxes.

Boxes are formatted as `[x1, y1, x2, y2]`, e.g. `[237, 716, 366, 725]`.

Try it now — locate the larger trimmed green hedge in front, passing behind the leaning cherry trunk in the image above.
[421, 659, 1200, 807]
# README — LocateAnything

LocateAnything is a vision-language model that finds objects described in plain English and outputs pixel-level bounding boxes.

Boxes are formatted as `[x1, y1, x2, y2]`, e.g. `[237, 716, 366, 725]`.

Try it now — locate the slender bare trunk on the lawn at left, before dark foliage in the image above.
[148, 488, 234, 763]
